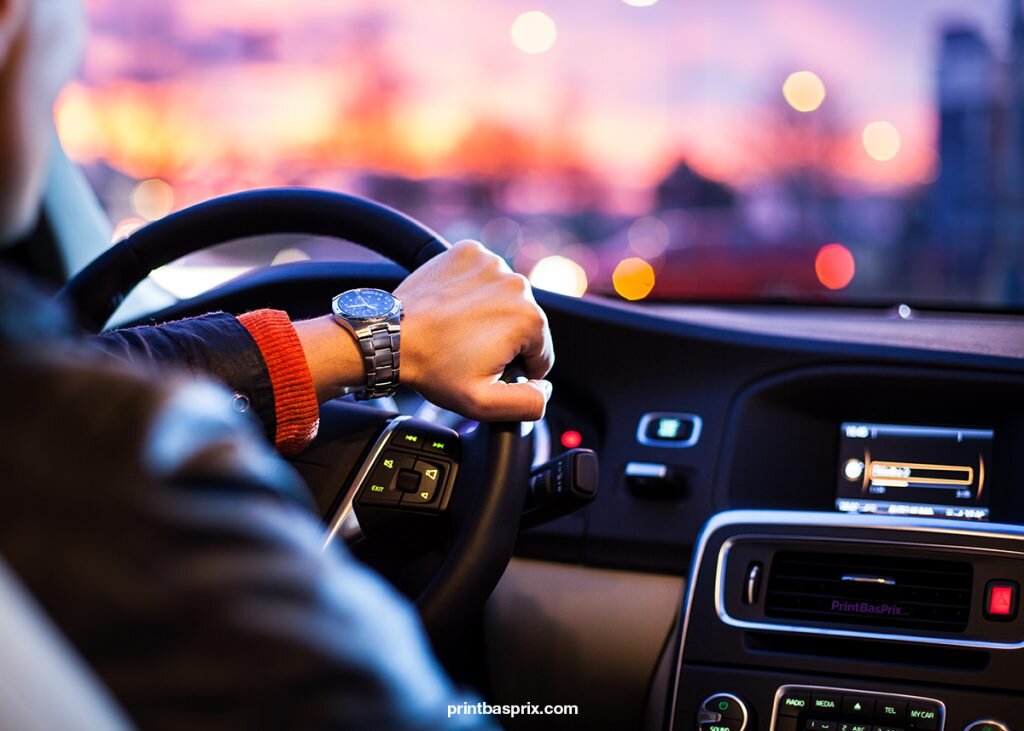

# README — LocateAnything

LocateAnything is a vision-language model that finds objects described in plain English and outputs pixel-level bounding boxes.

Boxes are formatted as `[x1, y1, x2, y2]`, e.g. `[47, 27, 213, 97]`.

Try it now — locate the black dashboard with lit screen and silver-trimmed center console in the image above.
[148, 264, 1024, 731]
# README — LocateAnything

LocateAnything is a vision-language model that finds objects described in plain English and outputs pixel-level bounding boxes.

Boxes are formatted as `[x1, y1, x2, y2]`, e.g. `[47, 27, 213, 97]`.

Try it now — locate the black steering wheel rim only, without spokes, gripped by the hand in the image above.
[57, 188, 531, 647]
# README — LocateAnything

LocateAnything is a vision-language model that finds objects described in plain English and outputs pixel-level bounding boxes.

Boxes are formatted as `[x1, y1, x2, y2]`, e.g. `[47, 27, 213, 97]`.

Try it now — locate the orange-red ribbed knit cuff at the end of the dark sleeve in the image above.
[239, 309, 319, 455]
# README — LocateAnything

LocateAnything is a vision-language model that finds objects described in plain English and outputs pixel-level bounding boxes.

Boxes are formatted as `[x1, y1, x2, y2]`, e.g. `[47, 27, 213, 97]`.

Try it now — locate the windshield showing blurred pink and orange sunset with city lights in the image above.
[57, 0, 1024, 308]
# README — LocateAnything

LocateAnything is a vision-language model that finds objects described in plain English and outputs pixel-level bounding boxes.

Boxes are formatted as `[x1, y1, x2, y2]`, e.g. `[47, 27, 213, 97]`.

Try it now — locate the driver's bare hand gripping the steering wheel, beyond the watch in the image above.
[394, 241, 555, 421]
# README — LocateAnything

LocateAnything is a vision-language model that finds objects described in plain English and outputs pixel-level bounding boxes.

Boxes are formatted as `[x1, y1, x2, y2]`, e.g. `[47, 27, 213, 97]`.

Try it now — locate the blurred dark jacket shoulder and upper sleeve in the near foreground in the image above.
[0, 350, 492, 731]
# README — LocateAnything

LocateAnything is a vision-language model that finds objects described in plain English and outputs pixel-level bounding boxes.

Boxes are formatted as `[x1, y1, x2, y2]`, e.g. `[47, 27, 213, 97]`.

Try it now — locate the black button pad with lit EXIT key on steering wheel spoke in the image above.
[357, 422, 460, 512]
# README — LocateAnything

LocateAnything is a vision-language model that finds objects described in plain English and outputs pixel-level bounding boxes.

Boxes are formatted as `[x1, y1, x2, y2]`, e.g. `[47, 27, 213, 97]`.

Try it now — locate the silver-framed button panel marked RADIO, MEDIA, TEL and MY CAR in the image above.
[771, 685, 946, 731]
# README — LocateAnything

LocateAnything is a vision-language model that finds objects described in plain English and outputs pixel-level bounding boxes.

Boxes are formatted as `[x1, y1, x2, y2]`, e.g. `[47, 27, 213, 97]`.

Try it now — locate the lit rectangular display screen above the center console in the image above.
[836, 422, 993, 520]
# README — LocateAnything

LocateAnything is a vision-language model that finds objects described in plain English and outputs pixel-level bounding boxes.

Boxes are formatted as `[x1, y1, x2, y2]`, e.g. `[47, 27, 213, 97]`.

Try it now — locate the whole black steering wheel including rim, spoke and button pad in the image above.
[58, 188, 531, 648]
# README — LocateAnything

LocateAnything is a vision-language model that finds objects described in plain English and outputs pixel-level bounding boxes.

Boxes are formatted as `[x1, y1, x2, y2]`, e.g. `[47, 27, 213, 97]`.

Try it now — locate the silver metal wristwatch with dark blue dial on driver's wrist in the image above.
[331, 288, 403, 400]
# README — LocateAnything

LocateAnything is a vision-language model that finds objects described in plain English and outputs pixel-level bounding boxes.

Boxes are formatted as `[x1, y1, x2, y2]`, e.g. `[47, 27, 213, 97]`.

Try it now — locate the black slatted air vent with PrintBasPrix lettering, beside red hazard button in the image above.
[765, 551, 974, 632]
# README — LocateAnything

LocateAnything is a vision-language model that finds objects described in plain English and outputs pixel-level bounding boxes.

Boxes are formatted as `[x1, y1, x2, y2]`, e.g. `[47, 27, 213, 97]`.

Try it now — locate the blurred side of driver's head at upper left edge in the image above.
[0, 0, 85, 246]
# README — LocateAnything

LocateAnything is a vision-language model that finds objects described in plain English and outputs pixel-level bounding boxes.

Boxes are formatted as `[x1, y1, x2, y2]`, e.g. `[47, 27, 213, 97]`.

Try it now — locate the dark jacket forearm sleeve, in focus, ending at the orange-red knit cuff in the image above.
[92, 312, 276, 439]
